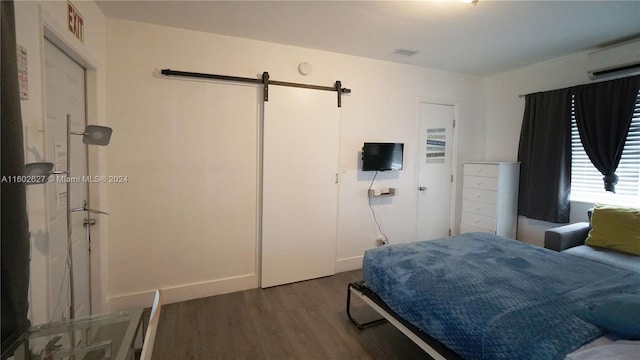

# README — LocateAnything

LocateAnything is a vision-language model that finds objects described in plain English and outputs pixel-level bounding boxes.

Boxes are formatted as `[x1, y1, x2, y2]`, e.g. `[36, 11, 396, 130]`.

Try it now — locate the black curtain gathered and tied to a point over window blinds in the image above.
[574, 76, 640, 193]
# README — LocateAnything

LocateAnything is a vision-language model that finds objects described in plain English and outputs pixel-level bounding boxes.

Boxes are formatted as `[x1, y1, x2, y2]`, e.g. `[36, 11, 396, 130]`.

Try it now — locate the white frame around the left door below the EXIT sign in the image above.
[38, 4, 107, 313]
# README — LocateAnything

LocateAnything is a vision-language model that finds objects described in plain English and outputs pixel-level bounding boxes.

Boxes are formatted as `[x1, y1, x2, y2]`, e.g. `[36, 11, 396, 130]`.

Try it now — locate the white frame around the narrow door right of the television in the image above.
[413, 97, 460, 240]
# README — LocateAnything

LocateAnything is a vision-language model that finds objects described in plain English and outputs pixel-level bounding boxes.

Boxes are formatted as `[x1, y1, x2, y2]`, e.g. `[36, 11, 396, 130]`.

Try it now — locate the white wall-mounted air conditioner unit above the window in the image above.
[588, 39, 640, 80]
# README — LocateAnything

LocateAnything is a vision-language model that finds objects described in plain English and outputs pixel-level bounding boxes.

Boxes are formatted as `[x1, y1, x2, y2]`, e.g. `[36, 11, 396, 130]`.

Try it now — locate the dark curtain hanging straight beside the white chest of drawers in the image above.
[518, 89, 571, 223]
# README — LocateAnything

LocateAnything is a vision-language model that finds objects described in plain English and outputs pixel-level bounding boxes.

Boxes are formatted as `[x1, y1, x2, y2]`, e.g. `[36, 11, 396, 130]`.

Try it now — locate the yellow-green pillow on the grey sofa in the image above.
[585, 204, 640, 256]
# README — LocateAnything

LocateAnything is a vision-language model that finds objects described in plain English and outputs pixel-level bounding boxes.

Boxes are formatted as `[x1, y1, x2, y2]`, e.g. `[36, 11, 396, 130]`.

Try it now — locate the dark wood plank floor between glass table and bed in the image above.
[153, 270, 429, 360]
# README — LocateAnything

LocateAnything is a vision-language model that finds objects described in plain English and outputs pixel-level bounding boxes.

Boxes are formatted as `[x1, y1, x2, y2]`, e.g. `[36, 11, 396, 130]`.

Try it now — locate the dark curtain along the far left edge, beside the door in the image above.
[0, 0, 29, 352]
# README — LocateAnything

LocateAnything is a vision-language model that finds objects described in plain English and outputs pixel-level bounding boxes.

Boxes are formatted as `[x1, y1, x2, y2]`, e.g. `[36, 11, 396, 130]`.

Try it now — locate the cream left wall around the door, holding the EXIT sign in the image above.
[14, 1, 106, 324]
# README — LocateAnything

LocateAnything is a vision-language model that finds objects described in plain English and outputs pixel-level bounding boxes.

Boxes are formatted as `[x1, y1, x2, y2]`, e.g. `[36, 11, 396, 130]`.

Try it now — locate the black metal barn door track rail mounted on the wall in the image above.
[161, 69, 351, 107]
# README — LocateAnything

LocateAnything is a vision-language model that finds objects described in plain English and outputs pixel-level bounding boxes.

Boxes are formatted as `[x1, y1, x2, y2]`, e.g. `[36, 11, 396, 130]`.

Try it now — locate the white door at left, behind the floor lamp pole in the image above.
[45, 40, 91, 320]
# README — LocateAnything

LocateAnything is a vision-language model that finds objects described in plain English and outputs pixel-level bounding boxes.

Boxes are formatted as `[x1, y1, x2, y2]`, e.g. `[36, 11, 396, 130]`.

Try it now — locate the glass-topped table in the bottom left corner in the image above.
[7, 309, 143, 360]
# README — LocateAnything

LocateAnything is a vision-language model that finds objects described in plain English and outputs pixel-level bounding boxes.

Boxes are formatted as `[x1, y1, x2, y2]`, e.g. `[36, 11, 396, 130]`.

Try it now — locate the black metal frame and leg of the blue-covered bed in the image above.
[347, 281, 462, 360]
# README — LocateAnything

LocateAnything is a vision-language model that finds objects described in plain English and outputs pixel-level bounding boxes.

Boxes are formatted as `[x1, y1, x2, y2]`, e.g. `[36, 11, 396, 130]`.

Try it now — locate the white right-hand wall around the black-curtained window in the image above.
[486, 53, 593, 246]
